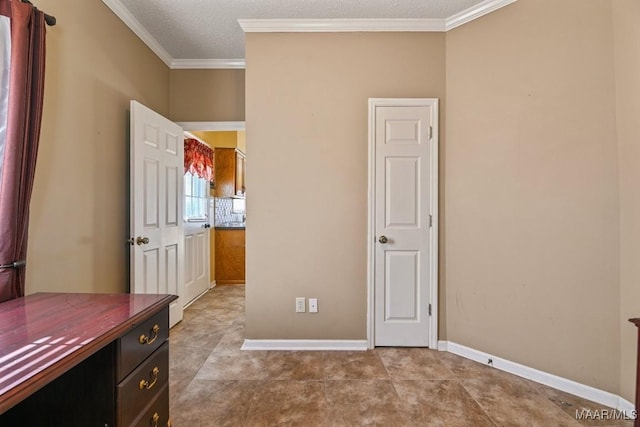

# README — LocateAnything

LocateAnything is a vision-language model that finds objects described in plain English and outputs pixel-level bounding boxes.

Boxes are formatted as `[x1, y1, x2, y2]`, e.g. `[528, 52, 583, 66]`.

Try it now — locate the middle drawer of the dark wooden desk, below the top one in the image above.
[116, 342, 169, 426]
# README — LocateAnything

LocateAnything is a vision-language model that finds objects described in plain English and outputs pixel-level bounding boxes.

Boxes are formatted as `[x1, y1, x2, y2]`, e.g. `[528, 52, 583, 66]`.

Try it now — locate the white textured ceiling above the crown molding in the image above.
[114, 0, 482, 60]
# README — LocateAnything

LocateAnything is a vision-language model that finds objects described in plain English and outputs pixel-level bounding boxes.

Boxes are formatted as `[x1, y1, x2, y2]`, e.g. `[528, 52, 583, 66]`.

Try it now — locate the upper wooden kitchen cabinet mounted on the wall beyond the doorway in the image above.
[213, 148, 245, 197]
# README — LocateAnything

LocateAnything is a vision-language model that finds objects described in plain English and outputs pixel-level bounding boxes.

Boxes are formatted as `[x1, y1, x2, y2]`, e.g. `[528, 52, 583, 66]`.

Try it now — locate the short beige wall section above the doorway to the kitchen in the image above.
[170, 70, 245, 122]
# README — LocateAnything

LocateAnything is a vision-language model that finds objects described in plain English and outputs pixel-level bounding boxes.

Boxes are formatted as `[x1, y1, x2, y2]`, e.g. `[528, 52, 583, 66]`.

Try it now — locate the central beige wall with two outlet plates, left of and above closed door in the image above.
[246, 33, 445, 339]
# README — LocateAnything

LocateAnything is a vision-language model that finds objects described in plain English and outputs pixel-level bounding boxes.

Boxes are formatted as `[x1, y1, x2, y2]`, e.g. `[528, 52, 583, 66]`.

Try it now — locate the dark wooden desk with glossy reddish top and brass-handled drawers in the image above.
[0, 293, 177, 427]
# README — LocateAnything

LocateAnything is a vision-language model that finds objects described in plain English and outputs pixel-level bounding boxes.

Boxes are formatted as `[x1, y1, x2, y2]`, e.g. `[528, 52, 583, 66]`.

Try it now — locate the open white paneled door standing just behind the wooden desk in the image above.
[130, 101, 184, 327]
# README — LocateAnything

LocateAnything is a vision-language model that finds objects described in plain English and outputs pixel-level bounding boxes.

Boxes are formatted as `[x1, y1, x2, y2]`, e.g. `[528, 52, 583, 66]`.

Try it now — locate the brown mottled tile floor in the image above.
[170, 286, 633, 427]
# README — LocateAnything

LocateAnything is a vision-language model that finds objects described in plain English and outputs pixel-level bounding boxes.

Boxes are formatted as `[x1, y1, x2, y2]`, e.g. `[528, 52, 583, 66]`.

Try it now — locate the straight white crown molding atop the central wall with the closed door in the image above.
[238, 19, 446, 33]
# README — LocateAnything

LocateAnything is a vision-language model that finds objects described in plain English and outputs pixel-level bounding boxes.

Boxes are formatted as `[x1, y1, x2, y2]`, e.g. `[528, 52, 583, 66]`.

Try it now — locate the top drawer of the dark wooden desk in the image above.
[116, 307, 169, 382]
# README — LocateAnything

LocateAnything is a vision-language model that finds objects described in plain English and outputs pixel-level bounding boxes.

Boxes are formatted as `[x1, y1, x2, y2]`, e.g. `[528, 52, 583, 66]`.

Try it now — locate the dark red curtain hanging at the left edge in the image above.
[0, 0, 45, 302]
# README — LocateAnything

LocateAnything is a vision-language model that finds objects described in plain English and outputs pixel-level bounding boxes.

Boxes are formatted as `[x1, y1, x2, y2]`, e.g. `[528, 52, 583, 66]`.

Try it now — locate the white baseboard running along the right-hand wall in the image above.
[438, 341, 635, 413]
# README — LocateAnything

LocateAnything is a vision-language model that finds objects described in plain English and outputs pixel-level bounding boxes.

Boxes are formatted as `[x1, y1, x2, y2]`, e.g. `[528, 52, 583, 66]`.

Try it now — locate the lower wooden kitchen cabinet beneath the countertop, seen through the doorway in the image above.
[215, 228, 245, 285]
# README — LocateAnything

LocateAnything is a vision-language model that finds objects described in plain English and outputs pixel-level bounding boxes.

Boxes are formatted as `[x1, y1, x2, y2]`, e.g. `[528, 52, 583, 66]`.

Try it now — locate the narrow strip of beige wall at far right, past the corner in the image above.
[612, 0, 640, 401]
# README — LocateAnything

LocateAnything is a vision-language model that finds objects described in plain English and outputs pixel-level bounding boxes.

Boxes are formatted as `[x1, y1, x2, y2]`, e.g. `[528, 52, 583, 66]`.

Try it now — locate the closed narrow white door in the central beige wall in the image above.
[370, 99, 437, 347]
